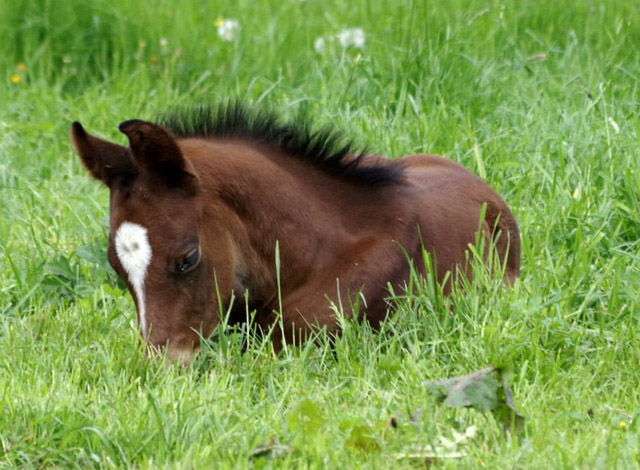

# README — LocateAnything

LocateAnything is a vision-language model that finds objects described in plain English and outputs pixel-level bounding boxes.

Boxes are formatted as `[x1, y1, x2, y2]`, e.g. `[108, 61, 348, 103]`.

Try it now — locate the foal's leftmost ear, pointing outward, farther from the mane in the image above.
[71, 122, 137, 187]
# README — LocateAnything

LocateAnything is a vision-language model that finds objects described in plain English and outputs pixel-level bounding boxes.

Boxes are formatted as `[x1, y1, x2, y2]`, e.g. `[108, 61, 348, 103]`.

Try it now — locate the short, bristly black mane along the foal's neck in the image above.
[159, 102, 402, 185]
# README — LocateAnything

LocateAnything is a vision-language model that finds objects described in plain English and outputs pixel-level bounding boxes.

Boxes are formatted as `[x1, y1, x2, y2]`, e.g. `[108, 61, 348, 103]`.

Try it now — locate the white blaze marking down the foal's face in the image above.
[115, 222, 152, 339]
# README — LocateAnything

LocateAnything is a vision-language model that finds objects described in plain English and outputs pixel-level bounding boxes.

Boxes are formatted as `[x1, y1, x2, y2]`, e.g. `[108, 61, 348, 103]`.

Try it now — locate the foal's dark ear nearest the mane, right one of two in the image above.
[118, 119, 196, 190]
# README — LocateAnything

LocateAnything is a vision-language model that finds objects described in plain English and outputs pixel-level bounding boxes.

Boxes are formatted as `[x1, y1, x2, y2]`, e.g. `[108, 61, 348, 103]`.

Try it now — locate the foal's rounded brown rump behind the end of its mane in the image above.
[401, 155, 520, 283]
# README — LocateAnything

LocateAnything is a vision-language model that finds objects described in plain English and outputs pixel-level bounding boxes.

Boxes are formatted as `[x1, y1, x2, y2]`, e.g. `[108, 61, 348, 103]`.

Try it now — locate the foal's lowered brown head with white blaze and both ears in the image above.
[71, 120, 218, 362]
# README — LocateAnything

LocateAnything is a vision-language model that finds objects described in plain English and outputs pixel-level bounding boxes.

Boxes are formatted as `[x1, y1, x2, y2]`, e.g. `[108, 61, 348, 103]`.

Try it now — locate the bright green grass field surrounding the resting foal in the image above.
[0, 0, 640, 469]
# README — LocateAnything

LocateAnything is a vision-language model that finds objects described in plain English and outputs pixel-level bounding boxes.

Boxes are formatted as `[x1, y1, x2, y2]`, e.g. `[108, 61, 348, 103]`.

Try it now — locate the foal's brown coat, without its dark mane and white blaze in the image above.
[72, 107, 520, 360]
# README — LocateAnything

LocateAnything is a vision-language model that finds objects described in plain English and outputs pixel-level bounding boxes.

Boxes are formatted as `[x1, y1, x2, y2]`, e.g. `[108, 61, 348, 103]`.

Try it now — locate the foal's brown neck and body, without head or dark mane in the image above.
[179, 138, 520, 341]
